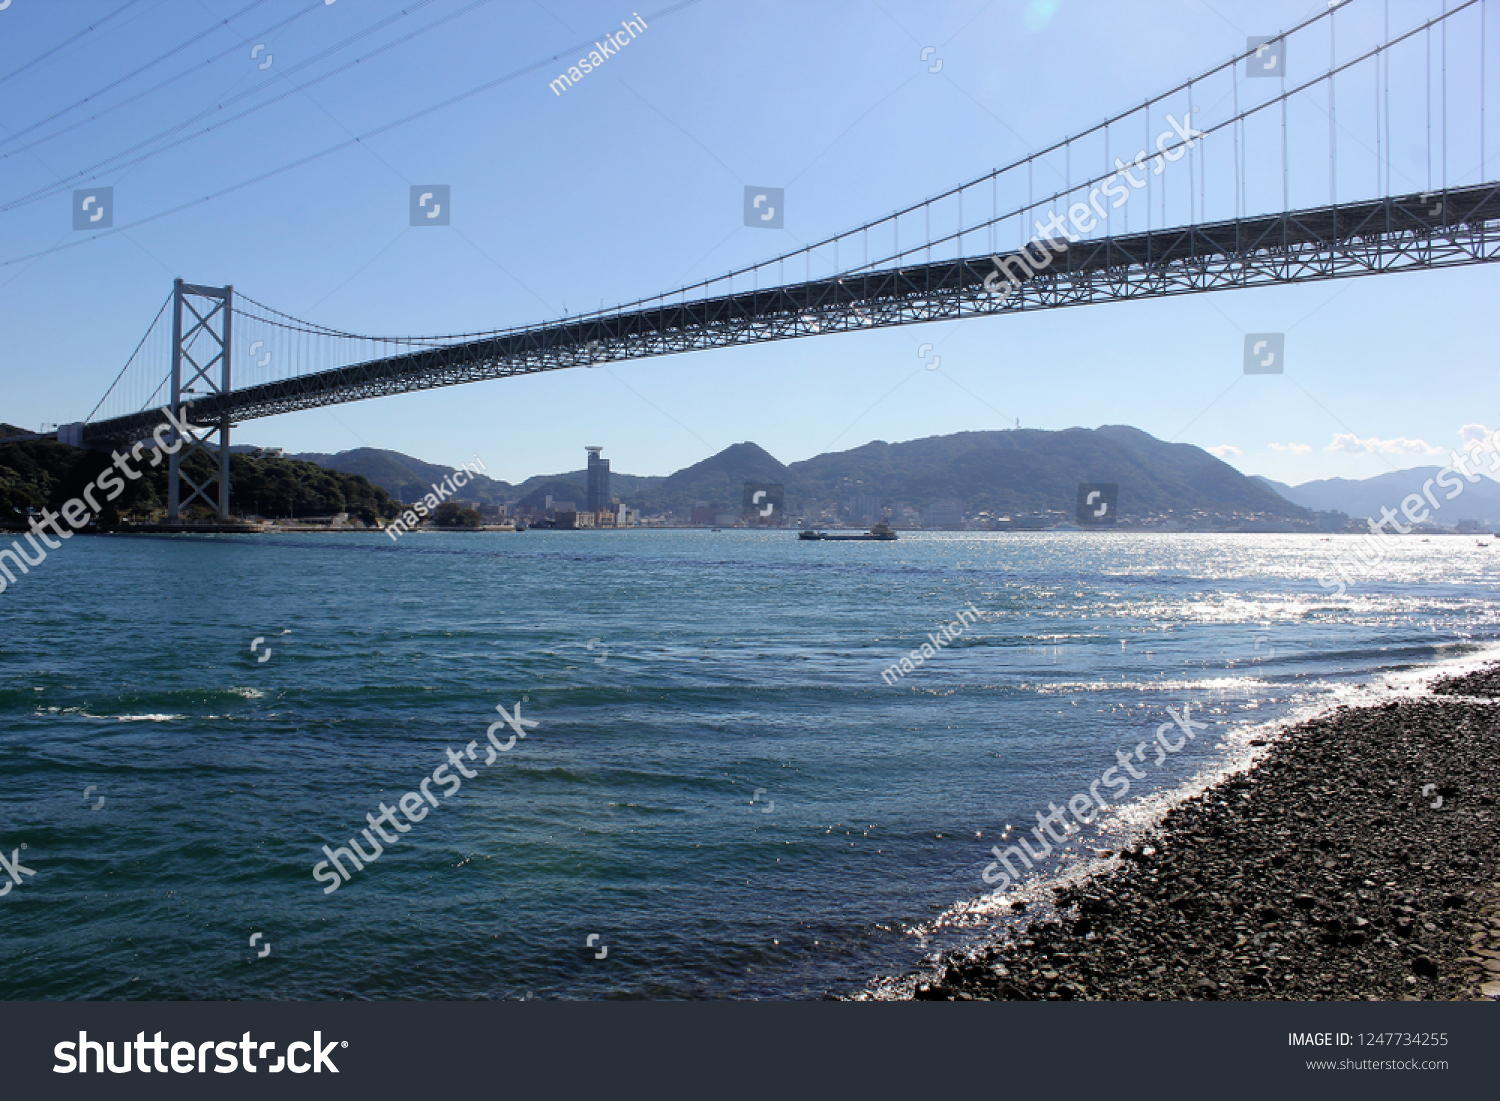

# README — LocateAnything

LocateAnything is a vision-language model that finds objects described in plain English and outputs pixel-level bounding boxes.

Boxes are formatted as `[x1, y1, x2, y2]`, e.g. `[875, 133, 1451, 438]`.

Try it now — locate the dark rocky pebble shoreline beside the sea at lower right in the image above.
[911, 666, 1500, 1001]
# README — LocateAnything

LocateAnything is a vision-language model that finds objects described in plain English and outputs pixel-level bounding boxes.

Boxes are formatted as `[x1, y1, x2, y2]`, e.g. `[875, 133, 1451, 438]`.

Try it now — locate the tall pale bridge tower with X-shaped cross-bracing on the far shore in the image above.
[167, 279, 234, 522]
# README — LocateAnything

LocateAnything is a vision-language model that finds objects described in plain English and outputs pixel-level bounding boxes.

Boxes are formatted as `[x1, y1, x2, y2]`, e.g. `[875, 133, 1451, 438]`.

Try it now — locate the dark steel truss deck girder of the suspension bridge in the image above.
[84, 183, 1500, 447]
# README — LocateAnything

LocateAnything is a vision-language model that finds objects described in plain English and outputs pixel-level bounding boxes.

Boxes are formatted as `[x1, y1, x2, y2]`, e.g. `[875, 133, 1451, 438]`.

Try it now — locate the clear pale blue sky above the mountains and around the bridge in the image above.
[0, 0, 1500, 483]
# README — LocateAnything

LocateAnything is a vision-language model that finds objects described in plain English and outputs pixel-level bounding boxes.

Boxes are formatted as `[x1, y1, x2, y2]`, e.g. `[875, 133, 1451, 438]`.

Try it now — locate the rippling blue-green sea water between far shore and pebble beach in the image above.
[0, 530, 1500, 999]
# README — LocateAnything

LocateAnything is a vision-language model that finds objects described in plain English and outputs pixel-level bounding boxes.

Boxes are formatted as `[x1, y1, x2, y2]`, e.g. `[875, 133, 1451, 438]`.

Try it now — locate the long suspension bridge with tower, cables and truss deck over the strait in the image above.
[14, 0, 1500, 519]
